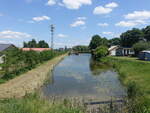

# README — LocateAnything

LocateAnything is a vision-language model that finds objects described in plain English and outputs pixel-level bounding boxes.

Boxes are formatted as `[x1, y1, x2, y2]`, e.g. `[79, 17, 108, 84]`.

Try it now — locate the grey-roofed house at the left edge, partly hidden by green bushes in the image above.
[0, 44, 16, 64]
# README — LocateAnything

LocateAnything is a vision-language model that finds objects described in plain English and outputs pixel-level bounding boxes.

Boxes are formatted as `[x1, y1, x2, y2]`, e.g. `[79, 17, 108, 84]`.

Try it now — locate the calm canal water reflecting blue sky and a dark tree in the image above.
[41, 54, 126, 100]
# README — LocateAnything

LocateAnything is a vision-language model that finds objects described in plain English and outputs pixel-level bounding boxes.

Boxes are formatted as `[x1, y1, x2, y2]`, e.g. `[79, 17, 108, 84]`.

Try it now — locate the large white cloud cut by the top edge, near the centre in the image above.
[62, 0, 92, 9]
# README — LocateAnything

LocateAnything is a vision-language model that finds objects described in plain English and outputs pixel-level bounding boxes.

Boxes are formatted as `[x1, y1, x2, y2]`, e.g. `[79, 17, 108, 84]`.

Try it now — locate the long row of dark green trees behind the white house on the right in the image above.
[89, 26, 150, 56]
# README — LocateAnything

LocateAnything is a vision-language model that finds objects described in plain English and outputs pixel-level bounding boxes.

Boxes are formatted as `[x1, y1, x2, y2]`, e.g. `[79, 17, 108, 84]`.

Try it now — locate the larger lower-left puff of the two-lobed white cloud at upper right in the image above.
[93, 6, 112, 15]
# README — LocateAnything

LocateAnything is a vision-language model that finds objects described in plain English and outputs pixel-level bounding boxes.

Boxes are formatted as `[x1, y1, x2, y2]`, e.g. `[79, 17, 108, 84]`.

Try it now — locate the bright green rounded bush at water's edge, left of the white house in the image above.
[93, 46, 108, 59]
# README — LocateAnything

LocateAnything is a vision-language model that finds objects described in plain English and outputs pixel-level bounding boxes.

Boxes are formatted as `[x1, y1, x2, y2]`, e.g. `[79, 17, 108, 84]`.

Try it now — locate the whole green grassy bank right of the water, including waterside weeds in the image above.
[100, 57, 150, 113]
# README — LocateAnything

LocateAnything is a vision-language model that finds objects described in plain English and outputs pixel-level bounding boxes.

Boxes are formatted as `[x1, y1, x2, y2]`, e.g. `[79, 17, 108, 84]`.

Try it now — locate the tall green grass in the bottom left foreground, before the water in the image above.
[0, 94, 83, 113]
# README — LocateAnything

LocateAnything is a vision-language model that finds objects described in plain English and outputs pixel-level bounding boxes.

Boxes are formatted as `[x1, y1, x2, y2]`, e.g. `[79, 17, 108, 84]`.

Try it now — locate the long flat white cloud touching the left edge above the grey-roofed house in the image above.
[0, 30, 31, 39]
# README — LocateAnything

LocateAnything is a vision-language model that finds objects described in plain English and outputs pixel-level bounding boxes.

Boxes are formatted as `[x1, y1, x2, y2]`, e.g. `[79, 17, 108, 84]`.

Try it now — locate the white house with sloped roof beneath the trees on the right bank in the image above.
[108, 46, 134, 56]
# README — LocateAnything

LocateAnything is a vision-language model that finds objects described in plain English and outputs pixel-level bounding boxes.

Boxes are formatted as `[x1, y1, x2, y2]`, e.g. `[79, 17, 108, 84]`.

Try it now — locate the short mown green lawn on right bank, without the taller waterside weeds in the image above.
[101, 57, 150, 98]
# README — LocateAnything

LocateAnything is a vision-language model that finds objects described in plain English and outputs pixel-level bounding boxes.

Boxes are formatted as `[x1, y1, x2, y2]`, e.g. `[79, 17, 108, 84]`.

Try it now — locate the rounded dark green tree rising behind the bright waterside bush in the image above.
[89, 35, 108, 50]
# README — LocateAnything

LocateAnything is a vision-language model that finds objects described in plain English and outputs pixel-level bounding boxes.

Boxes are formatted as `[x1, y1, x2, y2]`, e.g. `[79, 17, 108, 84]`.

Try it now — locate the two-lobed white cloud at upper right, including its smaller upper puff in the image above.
[93, 2, 118, 15]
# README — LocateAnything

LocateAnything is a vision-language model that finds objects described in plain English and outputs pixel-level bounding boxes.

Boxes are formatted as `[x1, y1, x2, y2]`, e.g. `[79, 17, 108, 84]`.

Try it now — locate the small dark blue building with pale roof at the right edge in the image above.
[138, 50, 150, 61]
